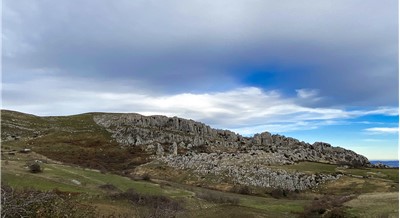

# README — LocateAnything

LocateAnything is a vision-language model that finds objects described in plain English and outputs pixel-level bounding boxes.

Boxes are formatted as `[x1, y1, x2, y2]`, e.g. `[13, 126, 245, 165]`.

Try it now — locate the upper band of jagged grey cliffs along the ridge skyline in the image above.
[94, 114, 369, 166]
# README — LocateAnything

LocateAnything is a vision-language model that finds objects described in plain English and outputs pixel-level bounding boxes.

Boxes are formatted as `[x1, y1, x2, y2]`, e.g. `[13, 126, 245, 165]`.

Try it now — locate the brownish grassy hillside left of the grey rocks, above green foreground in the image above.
[1, 110, 149, 172]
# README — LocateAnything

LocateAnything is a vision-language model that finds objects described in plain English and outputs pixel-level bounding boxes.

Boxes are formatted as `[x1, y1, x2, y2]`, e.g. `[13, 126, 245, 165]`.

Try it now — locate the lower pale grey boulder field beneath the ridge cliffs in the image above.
[159, 152, 341, 191]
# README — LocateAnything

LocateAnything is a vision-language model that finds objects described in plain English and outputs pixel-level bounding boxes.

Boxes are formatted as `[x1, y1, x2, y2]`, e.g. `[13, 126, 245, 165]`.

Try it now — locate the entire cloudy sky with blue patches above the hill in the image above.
[1, 0, 399, 160]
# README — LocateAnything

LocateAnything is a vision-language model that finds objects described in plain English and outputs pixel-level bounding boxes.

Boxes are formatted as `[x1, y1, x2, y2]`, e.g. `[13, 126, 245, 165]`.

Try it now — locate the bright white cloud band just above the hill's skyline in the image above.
[3, 76, 397, 135]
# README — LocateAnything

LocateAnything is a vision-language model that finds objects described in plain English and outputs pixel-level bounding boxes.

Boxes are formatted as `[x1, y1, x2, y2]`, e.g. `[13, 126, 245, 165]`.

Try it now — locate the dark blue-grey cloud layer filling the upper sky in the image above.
[3, 0, 398, 106]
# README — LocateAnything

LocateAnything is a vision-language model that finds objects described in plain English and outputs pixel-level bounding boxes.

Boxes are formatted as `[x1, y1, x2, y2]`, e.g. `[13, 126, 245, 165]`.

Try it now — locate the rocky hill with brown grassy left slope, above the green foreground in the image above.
[1, 110, 370, 191]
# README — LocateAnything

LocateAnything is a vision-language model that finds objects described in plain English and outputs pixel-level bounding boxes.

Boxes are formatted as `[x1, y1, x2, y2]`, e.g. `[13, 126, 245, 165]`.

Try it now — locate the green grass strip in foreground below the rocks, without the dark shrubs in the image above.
[1, 153, 310, 217]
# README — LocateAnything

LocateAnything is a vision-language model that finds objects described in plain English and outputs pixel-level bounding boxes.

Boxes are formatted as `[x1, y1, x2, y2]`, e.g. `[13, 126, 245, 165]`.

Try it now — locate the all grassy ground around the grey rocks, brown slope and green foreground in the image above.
[1, 110, 399, 217]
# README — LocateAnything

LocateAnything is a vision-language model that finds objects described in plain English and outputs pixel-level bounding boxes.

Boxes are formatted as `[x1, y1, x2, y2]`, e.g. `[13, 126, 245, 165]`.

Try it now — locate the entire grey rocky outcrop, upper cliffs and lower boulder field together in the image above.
[94, 114, 370, 191]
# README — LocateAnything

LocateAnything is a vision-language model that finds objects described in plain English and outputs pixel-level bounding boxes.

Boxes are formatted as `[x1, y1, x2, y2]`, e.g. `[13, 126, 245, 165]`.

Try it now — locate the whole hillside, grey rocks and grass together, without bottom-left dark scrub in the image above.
[1, 110, 398, 217]
